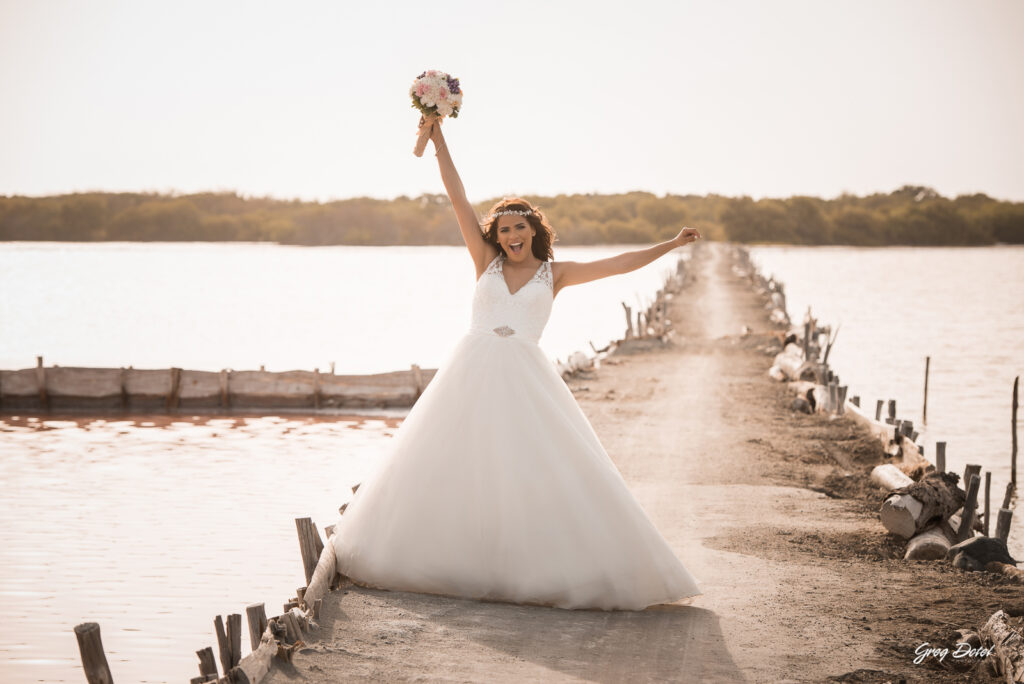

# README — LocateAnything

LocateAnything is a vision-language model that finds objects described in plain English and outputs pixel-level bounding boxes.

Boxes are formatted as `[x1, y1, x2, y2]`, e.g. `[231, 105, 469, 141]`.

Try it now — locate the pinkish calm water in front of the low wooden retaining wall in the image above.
[0, 416, 399, 682]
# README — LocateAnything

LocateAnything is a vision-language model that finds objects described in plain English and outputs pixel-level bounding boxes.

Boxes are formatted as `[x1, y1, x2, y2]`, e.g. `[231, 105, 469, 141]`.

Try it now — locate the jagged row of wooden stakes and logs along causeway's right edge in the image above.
[739, 244, 1024, 684]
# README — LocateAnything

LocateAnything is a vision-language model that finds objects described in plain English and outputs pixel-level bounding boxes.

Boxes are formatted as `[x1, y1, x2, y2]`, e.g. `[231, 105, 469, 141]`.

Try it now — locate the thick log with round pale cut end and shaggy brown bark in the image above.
[879, 472, 967, 539]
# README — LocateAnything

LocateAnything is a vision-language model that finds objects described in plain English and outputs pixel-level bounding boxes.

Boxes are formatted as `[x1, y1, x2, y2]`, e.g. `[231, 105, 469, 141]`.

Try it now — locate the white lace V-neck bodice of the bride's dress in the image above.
[470, 254, 554, 343]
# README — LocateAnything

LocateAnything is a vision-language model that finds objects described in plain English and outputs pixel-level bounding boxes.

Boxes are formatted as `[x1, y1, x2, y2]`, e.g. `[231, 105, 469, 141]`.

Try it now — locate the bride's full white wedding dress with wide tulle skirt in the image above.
[332, 255, 701, 610]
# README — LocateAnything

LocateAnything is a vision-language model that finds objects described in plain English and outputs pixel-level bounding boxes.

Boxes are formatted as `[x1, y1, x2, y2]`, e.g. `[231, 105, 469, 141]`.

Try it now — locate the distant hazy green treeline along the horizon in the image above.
[0, 185, 1024, 246]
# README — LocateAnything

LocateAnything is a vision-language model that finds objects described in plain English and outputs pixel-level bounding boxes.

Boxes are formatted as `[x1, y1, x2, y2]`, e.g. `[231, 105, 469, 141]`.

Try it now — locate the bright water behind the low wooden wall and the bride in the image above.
[0, 243, 689, 374]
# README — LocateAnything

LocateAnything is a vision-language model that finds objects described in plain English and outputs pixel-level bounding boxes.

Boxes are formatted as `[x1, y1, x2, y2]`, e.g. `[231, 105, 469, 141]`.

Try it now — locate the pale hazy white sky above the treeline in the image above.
[0, 0, 1024, 202]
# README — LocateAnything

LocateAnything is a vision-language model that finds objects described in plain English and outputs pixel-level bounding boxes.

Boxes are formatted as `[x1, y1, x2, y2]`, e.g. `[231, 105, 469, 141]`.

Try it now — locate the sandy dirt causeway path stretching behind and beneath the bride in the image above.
[264, 243, 1022, 684]
